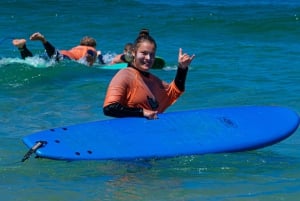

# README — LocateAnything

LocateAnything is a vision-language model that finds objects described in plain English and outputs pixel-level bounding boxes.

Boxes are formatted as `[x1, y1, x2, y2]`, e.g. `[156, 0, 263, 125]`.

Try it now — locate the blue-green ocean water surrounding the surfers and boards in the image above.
[0, 0, 300, 201]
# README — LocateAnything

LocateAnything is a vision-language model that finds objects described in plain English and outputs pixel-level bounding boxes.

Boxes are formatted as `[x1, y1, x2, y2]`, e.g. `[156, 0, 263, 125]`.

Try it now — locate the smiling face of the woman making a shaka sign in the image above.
[134, 41, 156, 71]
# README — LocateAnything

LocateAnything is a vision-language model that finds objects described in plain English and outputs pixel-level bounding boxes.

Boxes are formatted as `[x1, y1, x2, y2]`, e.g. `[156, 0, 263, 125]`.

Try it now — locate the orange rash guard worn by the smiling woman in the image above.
[103, 67, 183, 113]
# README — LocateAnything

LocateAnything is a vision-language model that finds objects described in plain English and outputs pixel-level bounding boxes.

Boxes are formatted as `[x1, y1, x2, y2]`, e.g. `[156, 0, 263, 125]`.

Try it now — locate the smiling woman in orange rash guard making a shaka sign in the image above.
[103, 29, 195, 119]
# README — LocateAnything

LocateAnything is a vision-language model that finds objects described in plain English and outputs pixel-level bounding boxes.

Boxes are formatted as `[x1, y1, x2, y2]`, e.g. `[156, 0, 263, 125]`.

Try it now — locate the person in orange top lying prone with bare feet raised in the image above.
[12, 32, 104, 66]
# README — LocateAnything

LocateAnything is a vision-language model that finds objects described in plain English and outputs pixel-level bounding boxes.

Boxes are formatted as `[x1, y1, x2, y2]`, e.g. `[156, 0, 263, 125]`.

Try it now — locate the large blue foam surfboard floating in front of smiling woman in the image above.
[23, 106, 299, 160]
